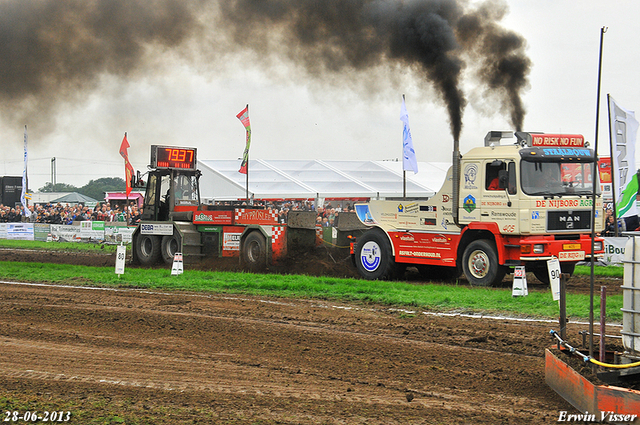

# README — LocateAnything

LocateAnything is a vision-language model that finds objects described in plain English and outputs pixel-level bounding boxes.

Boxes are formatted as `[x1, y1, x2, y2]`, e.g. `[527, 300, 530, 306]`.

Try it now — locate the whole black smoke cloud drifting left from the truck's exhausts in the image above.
[0, 0, 530, 139]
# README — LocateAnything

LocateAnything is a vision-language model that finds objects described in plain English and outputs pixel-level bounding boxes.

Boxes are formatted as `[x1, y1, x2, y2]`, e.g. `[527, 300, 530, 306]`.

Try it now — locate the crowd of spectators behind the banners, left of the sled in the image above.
[0, 202, 142, 225]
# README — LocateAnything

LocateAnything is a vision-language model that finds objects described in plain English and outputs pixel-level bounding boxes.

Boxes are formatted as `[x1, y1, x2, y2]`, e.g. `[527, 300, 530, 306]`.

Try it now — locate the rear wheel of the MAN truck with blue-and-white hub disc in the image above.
[355, 229, 398, 280]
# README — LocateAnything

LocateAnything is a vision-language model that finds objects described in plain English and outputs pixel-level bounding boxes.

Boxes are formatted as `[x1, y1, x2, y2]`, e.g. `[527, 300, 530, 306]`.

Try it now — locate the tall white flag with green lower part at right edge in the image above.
[609, 96, 638, 217]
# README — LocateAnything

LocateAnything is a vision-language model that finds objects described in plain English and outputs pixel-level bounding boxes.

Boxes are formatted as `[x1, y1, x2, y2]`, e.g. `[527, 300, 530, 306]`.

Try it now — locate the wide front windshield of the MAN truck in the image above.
[521, 161, 600, 196]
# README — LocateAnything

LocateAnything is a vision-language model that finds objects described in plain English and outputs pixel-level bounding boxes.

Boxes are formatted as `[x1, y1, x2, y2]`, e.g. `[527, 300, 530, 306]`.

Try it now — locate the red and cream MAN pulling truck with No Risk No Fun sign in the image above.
[352, 131, 604, 286]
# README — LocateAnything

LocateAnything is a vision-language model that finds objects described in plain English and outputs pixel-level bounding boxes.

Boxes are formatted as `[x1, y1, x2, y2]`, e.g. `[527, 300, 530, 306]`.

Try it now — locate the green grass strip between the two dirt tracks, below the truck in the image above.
[0, 262, 622, 321]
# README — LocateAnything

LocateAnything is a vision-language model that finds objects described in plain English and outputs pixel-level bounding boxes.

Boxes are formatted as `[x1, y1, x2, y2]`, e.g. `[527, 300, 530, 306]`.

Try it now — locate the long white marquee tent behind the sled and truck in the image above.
[198, 159, 450, 200]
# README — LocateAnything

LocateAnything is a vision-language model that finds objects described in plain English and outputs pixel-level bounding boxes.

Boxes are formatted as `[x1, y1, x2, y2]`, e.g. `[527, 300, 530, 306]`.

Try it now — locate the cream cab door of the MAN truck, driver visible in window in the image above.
[479, 160, 519, 234]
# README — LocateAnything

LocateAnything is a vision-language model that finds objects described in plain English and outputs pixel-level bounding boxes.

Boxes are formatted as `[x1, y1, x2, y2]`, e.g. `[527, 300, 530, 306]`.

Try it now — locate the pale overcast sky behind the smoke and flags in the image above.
[0, 0, 640, 191]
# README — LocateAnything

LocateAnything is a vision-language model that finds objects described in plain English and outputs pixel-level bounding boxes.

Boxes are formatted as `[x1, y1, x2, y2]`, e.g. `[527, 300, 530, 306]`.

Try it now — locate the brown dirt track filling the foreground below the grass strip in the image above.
[0, 247, 632, 424]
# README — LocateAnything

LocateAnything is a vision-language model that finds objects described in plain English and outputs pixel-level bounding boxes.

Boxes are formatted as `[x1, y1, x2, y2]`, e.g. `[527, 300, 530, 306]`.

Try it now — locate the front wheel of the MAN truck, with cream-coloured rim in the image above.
[462, 239, 507, 286]
